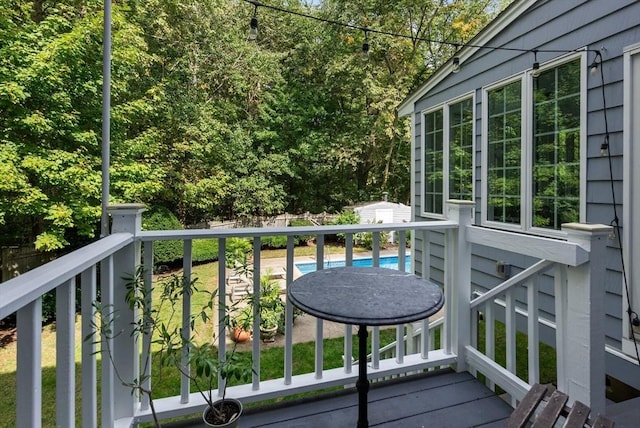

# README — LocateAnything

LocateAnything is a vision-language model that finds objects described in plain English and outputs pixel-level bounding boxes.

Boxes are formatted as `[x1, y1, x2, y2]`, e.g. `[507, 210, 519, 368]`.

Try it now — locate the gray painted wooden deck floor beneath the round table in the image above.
[164, 370, 513, 428]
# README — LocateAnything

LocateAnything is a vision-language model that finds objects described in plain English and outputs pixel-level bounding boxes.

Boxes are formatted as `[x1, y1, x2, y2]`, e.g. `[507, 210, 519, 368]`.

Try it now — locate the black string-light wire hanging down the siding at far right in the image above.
[593, 52, 640, 365]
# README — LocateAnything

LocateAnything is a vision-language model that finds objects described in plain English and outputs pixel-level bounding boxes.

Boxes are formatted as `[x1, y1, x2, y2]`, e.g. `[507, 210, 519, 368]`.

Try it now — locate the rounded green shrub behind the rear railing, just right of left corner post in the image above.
[142, 206, 184, 266]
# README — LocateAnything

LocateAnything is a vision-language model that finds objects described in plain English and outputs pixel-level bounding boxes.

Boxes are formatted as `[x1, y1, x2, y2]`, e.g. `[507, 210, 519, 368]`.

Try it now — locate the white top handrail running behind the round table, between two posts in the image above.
[136, 220, 458, 242]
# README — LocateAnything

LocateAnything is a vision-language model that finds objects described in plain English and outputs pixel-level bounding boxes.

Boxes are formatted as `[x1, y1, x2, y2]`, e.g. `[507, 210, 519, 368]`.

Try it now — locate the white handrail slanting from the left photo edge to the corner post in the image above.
[0, 233, 134, 319]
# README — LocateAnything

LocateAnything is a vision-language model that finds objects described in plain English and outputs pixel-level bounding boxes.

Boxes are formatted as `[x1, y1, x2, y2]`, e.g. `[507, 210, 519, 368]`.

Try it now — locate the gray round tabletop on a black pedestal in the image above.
[287, 267, 444, 326]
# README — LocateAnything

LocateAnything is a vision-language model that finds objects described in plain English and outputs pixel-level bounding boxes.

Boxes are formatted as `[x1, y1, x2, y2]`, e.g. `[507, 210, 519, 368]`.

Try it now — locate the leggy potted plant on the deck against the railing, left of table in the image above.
[85, 270, 252, 427]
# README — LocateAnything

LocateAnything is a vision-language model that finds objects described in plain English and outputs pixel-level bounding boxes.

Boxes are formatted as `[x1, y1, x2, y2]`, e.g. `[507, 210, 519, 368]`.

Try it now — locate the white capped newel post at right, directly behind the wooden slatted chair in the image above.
[556, 223, 613, 413]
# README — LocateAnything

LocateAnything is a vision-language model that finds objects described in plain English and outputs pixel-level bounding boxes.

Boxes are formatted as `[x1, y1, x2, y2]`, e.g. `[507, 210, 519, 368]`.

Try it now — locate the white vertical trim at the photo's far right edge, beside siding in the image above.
[622, 43, 640, 358]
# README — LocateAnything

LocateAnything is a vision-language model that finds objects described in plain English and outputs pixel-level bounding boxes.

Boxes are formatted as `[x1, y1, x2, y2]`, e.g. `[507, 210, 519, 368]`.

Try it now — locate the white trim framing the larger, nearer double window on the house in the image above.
[481, 51, 587, 238]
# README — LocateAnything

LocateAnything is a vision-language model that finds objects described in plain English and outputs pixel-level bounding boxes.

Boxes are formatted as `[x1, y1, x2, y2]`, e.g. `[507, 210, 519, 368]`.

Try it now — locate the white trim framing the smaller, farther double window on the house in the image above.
[420, 91, 477, 219]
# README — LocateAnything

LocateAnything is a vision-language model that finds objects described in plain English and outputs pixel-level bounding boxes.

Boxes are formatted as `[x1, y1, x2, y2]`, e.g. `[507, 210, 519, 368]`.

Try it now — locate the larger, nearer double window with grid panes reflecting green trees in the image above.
[482, 56, 584, 235]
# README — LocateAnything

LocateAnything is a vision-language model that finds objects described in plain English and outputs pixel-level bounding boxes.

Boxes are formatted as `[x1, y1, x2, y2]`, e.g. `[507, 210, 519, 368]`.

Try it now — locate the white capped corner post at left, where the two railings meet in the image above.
[103, 204, 145, 419]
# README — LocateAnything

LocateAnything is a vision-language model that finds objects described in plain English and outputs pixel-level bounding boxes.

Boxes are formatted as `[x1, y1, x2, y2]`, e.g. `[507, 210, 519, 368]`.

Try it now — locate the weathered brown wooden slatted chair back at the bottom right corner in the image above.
[507, 384, 613, 428]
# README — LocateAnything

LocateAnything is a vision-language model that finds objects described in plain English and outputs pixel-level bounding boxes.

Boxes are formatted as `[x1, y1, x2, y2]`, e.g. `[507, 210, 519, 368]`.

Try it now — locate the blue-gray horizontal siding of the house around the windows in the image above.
[404, 0, 640, 388]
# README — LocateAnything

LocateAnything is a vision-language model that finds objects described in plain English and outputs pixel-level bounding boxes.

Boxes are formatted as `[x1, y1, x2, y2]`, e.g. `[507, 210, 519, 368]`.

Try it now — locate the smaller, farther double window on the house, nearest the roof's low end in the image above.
[423, 97, 473, 215]
